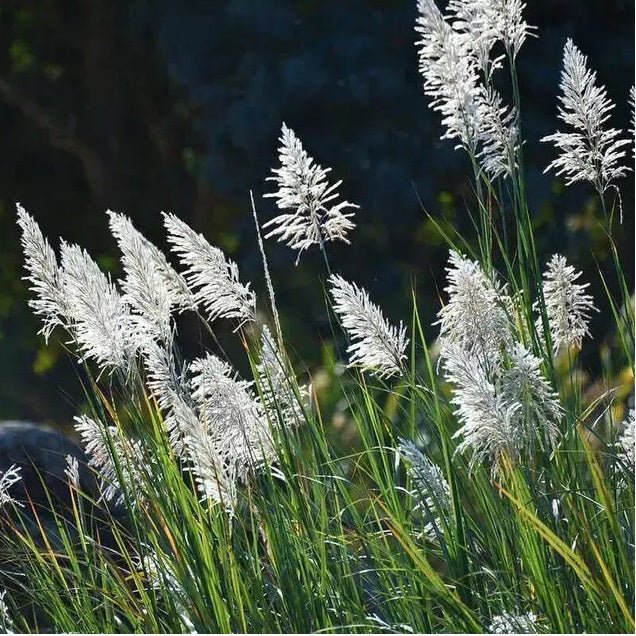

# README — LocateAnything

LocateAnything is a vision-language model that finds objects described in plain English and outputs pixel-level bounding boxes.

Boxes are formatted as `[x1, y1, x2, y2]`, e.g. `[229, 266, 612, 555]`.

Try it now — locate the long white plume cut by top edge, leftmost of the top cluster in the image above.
[415, 0, 483, 155]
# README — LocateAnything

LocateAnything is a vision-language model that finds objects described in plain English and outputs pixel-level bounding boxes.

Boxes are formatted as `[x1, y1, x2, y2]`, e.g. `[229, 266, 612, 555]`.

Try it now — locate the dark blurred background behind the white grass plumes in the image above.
[0, 0, 634, 424]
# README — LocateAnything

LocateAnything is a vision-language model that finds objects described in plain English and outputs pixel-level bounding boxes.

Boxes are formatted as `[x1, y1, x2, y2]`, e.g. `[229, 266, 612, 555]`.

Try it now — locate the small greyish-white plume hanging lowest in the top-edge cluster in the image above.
[477, 88, 520, 179]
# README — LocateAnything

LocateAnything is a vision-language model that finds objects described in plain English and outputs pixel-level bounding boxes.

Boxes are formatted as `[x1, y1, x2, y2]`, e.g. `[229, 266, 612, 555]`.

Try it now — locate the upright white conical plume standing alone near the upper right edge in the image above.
[542, 39, 631, 193]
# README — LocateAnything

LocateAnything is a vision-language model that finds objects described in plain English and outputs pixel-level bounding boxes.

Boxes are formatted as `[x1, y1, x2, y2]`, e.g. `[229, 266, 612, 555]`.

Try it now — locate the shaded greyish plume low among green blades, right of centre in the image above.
[398, 439, 451, 539]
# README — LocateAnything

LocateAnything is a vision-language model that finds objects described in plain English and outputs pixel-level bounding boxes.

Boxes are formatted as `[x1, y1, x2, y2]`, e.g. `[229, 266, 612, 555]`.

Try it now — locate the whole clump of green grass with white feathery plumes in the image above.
[0, 0, 634, 633]
